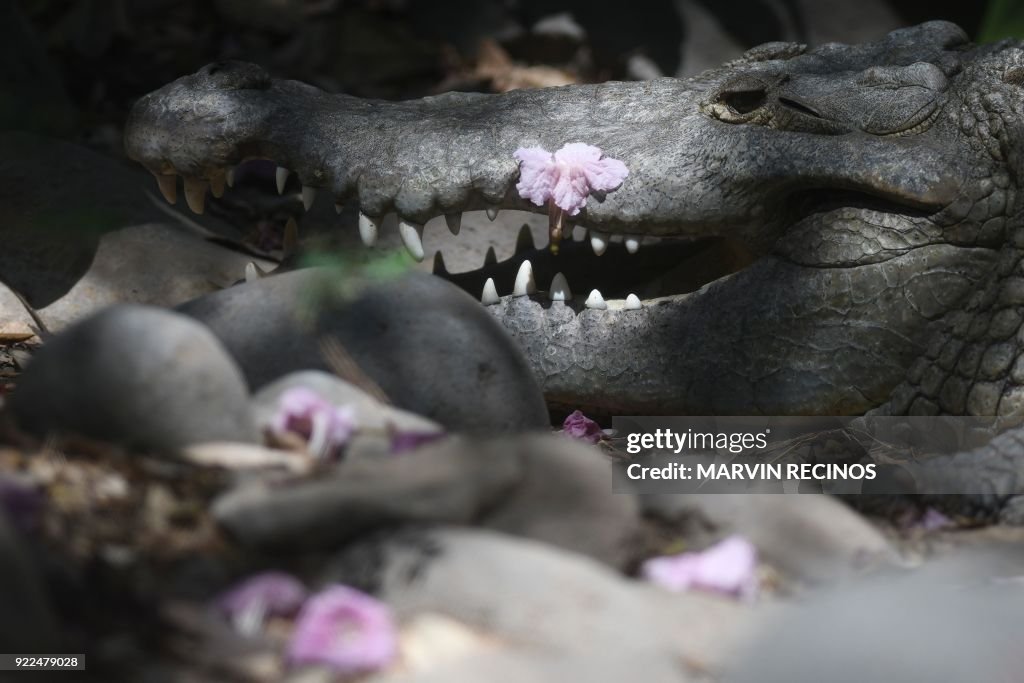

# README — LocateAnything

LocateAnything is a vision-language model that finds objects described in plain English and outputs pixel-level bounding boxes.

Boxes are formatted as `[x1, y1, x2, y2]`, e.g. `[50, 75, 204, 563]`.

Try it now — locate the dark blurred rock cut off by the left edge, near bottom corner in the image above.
[0, 510, 60, 653]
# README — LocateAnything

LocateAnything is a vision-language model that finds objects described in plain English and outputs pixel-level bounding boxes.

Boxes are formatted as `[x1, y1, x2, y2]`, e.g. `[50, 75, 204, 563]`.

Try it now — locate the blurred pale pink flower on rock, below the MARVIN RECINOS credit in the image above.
[640, 536, 758, 599]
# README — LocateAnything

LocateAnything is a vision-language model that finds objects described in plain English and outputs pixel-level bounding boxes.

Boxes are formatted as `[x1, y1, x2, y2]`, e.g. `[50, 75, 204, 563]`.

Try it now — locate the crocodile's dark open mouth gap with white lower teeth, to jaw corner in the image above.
[433, 188, 933, 312]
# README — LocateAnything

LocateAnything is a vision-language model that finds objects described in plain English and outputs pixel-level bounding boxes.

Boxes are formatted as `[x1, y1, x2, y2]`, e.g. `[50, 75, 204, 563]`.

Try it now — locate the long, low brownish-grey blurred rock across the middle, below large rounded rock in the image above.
[213, 435, 640, 566]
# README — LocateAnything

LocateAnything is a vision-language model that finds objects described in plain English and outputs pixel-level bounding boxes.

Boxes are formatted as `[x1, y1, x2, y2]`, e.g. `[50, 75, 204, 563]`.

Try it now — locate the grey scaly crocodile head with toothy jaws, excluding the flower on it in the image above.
[125, 22, 1024, 414]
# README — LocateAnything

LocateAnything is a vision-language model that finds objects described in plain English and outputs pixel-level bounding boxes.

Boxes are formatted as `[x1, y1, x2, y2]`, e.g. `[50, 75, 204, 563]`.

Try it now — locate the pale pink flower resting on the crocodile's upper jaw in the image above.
[513, 142, 629, 216]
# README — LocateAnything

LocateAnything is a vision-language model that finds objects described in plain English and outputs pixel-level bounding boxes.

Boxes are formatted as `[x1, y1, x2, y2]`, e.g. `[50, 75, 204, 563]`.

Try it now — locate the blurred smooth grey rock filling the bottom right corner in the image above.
[728, 551, 1024, 683]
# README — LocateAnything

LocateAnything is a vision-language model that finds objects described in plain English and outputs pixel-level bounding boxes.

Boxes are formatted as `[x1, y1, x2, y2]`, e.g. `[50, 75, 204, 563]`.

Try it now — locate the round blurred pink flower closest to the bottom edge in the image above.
[288, 585, 398, 675]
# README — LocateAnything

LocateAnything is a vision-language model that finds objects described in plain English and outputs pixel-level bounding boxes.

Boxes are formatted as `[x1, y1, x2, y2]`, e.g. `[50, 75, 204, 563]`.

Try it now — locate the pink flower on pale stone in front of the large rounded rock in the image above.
[270, 386, 355, 458]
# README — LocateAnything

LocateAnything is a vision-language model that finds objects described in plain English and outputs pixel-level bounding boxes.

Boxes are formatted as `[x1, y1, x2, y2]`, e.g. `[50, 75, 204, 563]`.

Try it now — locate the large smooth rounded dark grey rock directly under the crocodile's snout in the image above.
[179, 268, 548, 434]
